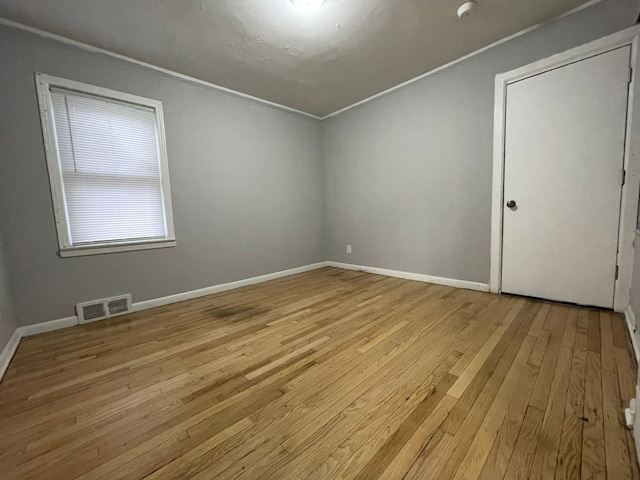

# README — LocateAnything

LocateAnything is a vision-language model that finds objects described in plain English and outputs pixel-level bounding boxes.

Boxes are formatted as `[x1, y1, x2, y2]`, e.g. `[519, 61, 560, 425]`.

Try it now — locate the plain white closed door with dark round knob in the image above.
[502, 46, 631, 308]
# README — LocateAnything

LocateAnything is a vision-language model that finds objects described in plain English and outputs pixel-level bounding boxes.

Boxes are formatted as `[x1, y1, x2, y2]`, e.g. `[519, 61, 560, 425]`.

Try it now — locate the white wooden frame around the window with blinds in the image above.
[36, 72, 176, 257]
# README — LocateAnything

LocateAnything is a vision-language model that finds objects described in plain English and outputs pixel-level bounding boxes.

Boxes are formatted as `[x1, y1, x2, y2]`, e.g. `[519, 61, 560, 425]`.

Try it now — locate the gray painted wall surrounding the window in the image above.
[0, 27, 324, 325]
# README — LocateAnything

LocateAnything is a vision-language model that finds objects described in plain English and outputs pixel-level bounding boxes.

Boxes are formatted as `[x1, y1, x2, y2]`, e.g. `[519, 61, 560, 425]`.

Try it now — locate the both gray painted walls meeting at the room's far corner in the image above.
[0, 0, 637, 335]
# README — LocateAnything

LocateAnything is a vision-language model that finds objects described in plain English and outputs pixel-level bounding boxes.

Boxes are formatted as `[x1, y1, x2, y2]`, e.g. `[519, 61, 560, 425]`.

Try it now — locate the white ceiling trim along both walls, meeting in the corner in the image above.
[0, 0, 616, 120]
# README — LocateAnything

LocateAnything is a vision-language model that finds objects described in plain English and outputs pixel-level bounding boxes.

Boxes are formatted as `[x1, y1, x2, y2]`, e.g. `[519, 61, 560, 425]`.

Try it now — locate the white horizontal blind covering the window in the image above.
[50, 87, 168, 247]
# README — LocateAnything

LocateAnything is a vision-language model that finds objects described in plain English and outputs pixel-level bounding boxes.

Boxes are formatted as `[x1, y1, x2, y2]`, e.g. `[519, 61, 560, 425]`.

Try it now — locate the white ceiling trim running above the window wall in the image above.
[0, 18, 321, 120]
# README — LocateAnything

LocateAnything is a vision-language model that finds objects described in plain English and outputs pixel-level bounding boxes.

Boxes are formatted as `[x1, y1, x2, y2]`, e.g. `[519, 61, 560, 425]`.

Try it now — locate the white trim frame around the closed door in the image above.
[489, 25, 640, 312]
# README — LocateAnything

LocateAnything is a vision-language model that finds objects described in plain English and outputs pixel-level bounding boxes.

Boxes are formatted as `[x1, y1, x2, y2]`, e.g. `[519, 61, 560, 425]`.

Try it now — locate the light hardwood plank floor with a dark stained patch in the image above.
[0, 268, 640, 480]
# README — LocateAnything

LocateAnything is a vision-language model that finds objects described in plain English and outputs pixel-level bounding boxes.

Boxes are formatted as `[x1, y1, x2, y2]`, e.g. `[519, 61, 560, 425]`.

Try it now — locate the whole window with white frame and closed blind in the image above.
[36, 74, 175, 257]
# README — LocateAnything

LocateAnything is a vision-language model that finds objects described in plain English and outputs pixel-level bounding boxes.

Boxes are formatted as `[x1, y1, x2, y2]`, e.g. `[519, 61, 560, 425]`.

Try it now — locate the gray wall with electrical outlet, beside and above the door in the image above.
[323, 0, 638, 283]
